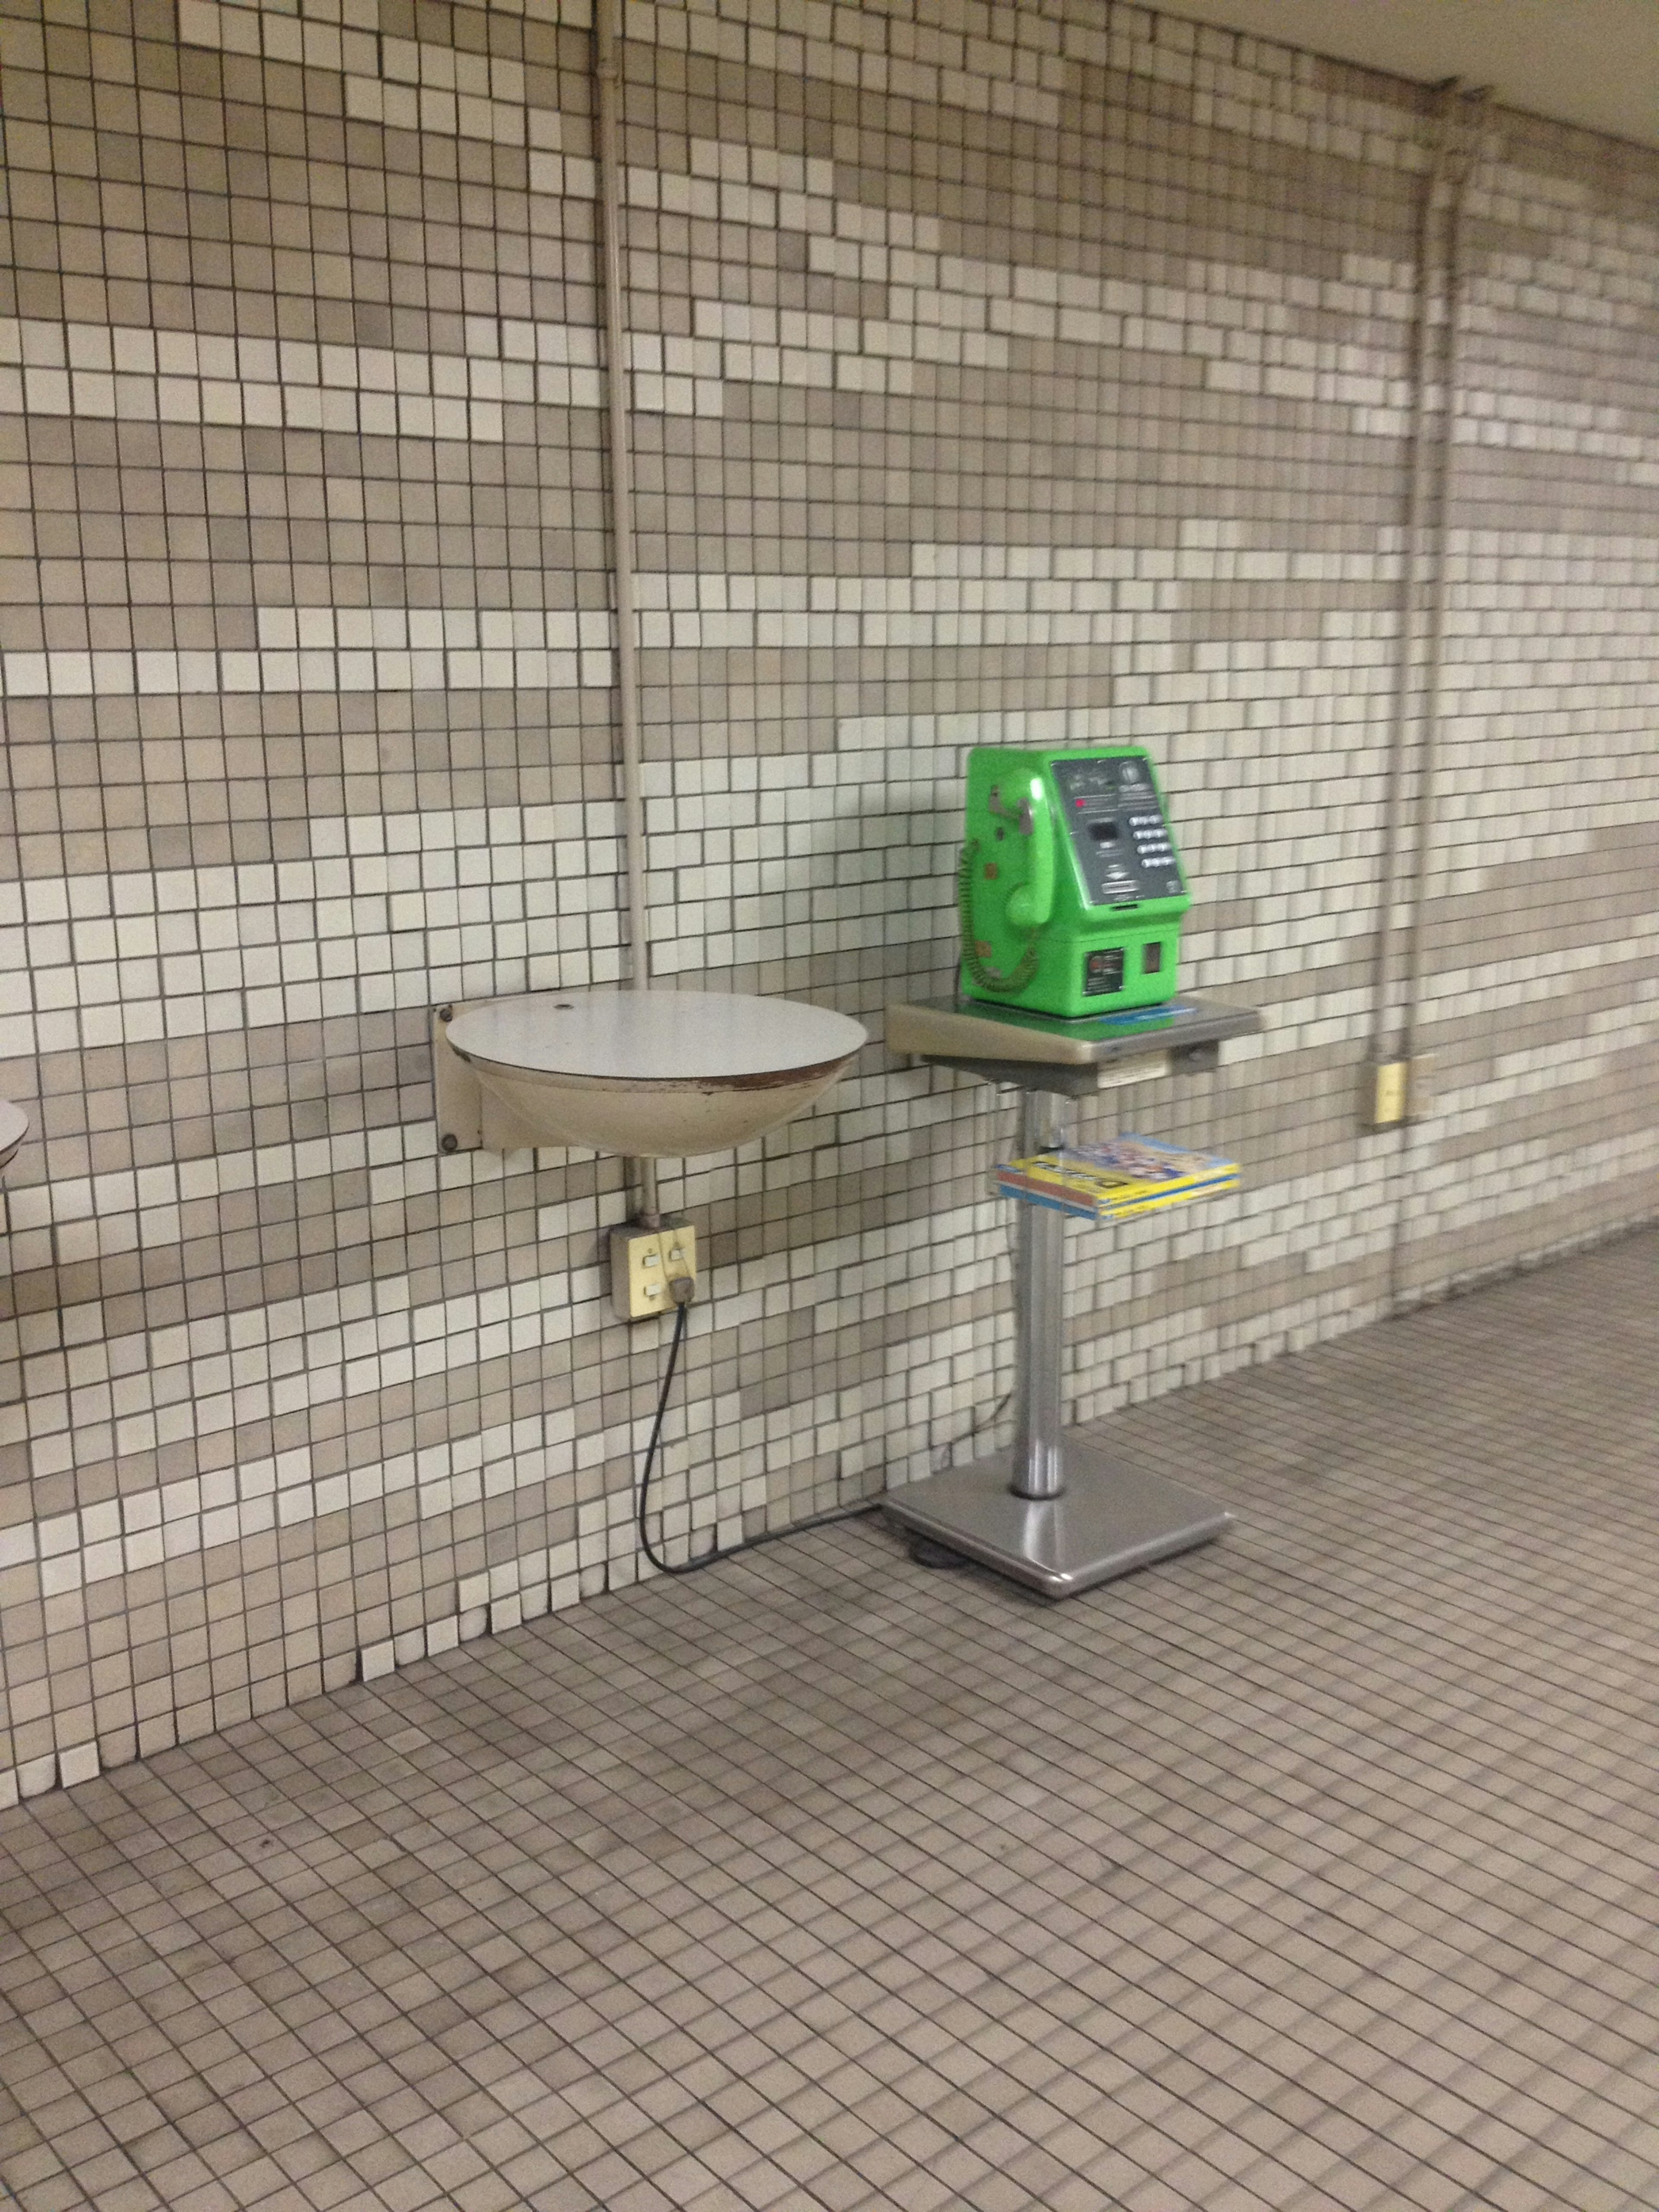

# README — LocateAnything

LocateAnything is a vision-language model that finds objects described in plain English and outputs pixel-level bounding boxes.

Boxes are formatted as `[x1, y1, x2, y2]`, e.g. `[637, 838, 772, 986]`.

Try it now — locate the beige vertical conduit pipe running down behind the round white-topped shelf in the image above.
[593, 0, 661, 1228]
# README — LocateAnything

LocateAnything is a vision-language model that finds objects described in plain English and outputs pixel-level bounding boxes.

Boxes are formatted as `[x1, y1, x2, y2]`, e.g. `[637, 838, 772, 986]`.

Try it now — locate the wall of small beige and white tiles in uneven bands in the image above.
[0, 0, 1659, 1801]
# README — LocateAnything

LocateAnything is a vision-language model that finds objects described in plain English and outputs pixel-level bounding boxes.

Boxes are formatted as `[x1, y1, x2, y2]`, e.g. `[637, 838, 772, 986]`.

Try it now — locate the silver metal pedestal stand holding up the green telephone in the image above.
[885, 998, 1261, 1597]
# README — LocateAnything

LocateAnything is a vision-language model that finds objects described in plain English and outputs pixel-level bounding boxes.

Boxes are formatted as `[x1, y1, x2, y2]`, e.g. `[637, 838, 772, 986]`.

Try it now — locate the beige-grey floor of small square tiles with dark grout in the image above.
[0, 1234, 1659, 2212]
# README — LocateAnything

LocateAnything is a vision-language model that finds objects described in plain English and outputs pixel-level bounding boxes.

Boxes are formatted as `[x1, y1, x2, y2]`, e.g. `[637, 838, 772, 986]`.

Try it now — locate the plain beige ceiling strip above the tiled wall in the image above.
[1163, 0, 1659, 146]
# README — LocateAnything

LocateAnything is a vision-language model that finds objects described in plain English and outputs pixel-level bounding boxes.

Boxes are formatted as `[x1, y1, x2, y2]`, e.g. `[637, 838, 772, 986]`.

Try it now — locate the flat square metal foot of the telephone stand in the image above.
[885, 1436, 1232, 1597]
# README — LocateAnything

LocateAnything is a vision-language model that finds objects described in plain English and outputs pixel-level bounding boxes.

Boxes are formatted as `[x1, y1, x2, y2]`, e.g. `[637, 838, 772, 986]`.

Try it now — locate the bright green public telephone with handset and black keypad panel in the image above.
[958, 745, 1192, 1017]
